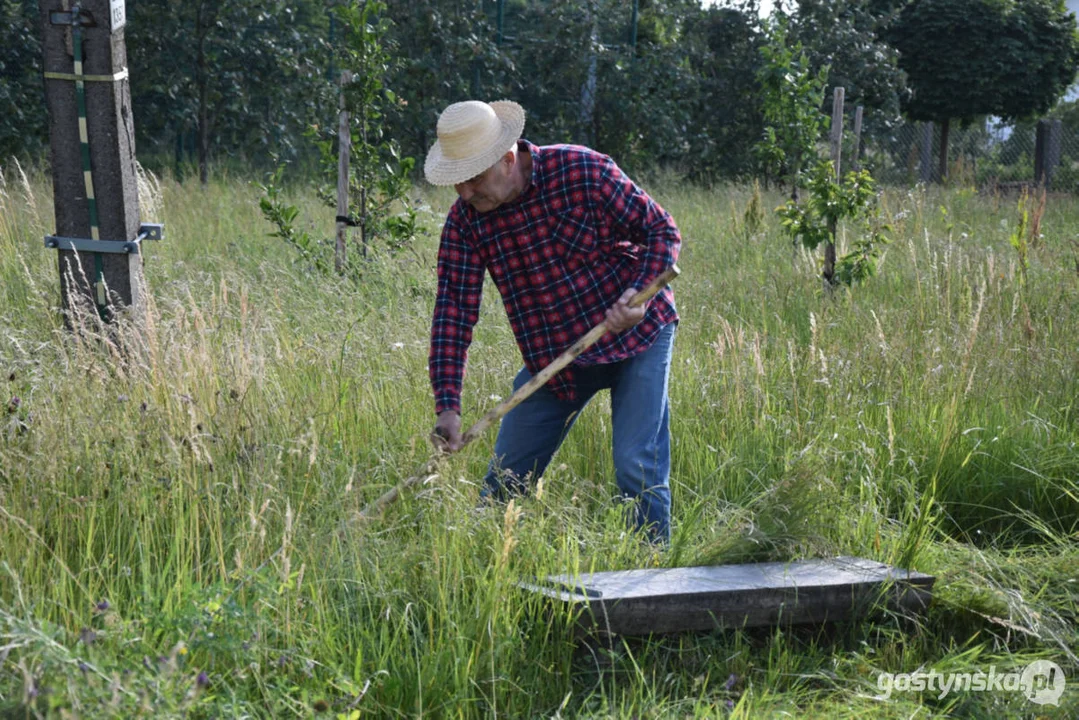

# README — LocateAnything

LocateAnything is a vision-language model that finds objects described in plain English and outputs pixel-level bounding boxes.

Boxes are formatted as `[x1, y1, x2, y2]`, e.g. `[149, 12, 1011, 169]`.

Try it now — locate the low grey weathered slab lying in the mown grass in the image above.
[521, 557, 935, 635]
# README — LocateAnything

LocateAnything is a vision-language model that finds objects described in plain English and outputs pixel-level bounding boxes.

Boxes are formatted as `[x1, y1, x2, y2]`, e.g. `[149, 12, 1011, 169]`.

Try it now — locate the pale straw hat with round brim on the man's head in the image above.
[423, 100, 524, 185]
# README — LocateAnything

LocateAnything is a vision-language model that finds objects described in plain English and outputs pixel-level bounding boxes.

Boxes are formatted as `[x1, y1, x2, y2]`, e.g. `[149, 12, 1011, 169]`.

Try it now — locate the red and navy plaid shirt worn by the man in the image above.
[428, 140, 681, 412]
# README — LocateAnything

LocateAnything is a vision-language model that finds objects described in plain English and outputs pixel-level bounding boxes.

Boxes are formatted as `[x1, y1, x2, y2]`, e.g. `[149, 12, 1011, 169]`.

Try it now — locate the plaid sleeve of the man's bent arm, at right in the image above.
[596, 155, 682, 290]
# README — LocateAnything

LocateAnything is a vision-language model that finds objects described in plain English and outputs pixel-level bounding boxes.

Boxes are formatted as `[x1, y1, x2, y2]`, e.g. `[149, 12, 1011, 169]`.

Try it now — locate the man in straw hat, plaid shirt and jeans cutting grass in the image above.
[424, 100, 681, 542]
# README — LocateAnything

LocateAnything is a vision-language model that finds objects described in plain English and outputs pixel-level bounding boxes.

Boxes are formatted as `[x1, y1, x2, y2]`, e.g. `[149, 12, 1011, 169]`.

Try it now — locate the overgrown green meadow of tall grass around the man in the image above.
[0, 165, 1079, 718]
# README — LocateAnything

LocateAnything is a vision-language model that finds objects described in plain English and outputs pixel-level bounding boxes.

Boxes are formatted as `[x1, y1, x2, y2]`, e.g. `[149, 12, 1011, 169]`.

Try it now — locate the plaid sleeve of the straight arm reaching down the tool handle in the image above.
[427, 204, 484, 413]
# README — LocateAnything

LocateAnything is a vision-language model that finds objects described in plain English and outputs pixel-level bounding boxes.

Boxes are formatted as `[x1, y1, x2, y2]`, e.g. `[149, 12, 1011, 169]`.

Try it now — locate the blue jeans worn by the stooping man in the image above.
[482, 323, 677, 542]
